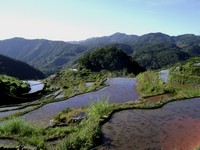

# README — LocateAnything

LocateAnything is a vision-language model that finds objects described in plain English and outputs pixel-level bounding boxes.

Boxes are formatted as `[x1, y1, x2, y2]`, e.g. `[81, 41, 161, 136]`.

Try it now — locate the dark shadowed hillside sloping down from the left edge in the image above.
[0, 55, 45, 79]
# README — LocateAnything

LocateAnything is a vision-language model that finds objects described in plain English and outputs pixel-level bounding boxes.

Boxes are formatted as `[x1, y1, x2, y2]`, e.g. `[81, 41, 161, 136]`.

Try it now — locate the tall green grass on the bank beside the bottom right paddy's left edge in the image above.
[58, 100, 115, 150]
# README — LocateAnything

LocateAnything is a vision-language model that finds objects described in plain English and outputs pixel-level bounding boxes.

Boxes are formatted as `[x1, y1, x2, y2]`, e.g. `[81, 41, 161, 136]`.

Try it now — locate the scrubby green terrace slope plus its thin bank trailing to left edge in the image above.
[0, 70, 110, 121]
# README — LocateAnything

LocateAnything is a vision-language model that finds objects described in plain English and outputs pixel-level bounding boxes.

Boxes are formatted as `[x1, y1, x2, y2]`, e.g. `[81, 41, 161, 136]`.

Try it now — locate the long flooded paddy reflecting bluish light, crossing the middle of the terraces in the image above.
[22, 78, 139, 126]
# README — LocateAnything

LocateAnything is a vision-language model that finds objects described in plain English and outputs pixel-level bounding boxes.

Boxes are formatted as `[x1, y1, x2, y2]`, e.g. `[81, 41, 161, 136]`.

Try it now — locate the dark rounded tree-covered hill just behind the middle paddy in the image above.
[78, 46, 145, 75]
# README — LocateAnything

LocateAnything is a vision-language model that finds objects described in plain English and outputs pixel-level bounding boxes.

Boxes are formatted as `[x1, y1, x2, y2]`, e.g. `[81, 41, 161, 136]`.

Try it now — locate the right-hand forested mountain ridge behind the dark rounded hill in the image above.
[78, 32, 200, 69]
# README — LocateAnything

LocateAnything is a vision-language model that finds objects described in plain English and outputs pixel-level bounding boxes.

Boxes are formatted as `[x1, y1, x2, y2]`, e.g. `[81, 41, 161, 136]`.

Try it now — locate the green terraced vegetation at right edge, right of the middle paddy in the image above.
[137, 58, 200, 99]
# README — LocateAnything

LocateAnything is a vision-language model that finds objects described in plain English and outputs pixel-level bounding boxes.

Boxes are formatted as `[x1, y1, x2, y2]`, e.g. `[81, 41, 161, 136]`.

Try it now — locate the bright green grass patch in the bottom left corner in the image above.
[0, 118, 76, 149]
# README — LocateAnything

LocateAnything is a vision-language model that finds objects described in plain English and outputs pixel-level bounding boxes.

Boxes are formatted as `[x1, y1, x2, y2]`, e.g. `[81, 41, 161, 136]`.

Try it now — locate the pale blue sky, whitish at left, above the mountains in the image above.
[0, 0, 200, 41]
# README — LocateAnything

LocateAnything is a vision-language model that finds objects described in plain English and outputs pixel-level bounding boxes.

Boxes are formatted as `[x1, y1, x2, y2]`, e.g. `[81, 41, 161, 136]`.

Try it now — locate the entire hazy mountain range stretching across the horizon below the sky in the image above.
[0, 33, 200, 75]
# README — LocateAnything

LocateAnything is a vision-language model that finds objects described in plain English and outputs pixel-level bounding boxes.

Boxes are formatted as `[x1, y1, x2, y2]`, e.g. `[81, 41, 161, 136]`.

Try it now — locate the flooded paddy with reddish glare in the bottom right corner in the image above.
[97, 98, 200, 150]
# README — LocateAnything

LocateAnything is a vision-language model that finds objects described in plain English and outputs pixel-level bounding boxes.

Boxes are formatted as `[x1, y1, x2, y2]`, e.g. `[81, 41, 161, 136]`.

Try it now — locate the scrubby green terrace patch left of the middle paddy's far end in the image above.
[46, 69, 108, 98]
